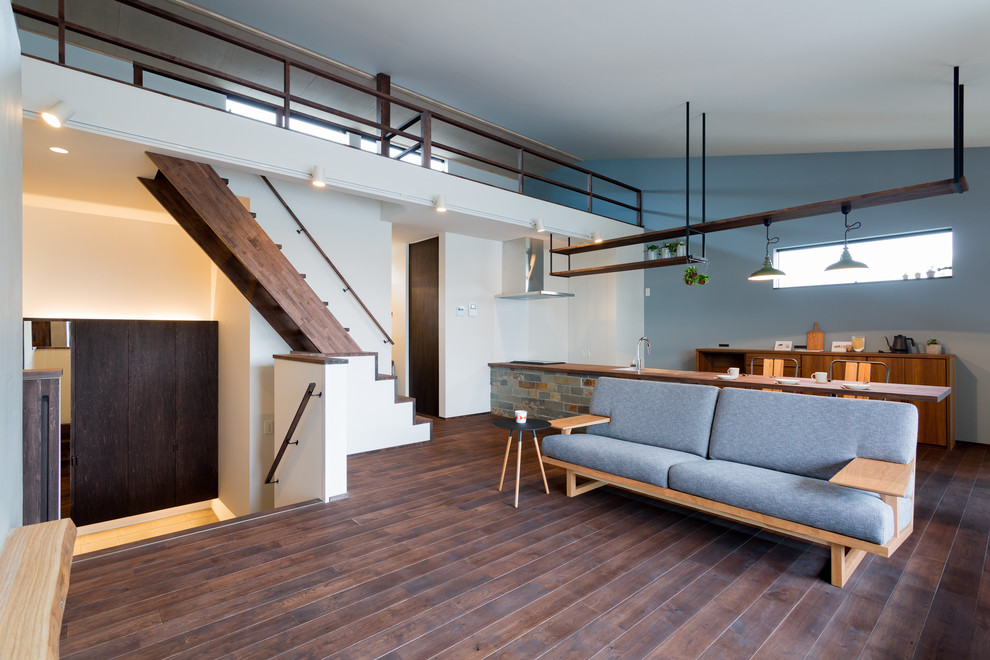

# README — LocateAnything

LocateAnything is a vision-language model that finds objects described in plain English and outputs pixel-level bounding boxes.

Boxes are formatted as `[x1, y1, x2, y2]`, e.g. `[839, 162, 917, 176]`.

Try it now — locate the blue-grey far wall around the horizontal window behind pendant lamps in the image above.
[586, 148, 990, 444]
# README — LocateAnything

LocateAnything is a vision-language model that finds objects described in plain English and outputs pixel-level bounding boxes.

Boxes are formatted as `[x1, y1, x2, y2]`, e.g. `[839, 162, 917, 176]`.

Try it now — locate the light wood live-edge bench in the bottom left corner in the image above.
[0, 518, 76, 660]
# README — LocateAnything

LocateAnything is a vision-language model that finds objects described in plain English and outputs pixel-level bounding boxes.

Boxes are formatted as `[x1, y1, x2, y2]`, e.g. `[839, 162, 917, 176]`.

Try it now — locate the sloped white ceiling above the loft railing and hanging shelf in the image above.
[182, 0, 990, 159]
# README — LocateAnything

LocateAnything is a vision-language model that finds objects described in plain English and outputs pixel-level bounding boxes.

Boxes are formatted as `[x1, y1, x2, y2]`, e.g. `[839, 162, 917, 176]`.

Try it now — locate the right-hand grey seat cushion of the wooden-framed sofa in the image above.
[670, 460, 894, 544]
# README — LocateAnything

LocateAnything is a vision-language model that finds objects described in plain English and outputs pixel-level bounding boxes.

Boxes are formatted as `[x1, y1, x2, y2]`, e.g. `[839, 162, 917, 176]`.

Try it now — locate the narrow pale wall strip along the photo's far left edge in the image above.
[0, 2, 23, 546]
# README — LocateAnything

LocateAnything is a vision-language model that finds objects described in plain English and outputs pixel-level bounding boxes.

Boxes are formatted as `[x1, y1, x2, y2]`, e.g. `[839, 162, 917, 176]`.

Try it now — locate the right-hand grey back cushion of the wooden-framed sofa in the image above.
[709, 387, 918, 479]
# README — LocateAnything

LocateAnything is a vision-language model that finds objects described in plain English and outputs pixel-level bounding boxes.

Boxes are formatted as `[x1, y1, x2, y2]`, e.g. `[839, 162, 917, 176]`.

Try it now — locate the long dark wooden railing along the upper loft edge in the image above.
[12, 0, 643, 226]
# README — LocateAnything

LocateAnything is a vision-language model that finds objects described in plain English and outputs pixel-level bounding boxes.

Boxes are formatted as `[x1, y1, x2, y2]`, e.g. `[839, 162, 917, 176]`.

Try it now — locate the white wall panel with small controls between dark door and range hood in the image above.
[440, 234, 502, 417]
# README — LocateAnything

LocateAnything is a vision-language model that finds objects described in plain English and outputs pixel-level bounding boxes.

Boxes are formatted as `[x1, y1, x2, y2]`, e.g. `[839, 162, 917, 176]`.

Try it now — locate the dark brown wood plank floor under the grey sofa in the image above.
[61, 415, 990, 660]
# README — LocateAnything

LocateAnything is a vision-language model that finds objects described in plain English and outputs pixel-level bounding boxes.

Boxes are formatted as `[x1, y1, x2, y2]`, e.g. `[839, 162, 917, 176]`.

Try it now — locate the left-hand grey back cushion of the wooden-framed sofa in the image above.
[589, 378, 718, 456]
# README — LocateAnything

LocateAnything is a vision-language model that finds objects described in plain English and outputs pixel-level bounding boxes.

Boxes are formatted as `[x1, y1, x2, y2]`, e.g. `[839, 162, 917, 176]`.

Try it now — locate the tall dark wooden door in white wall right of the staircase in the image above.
[408, 238, 440, 416]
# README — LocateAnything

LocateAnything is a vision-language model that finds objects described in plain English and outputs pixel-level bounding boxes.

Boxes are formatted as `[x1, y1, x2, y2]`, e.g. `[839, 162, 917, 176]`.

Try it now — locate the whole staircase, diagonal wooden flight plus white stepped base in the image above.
[139, 152, 432, 454]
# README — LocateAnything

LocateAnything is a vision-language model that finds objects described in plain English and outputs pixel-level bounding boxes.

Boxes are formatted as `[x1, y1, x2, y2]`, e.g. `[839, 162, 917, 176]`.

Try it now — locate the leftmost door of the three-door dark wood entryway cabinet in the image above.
[70, 320, 129, 526]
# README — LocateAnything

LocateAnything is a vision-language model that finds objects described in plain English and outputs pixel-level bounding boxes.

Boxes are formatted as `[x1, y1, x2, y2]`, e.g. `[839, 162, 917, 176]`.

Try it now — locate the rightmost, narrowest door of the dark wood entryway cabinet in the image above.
[175, 322, 218, 506]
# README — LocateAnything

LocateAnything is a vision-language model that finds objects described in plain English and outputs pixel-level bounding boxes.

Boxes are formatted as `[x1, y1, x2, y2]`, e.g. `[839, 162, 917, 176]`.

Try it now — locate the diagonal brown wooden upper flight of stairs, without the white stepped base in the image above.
[139, 152, 361, 354]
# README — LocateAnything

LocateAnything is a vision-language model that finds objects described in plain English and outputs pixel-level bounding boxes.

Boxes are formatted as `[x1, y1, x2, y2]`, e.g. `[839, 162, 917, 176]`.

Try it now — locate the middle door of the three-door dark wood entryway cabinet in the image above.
[127, 321, 177, 516]
